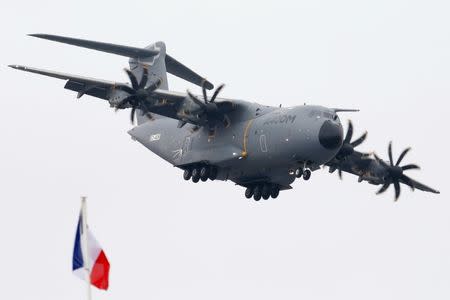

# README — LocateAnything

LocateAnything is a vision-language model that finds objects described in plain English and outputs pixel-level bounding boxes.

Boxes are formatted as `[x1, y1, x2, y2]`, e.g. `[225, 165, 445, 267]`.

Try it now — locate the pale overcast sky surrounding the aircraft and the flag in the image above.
[0, 0, 450, 300]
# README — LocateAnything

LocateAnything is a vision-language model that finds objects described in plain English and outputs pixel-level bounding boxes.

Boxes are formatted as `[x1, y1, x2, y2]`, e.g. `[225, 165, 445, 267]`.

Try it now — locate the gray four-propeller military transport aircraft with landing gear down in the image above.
[10, 34, 439, 201]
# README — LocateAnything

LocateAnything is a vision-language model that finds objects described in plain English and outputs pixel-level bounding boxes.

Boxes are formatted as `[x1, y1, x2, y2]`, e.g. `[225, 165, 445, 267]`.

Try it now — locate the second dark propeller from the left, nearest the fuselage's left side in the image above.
[187, 80, 234, 131]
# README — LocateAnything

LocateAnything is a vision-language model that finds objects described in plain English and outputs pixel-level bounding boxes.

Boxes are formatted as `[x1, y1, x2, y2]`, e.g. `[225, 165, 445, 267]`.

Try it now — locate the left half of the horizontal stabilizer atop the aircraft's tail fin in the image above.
[29, 34, 159, 58]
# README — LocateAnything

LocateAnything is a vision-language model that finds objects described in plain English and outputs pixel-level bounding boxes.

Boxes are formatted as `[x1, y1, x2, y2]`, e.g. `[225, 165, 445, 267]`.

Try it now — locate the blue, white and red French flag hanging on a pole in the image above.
[72, 212, 109, 290]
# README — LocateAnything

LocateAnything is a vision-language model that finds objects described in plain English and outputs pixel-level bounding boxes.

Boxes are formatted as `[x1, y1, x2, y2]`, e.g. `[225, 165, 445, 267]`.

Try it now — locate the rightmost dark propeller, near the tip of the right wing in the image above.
[374, 142, 420, 201]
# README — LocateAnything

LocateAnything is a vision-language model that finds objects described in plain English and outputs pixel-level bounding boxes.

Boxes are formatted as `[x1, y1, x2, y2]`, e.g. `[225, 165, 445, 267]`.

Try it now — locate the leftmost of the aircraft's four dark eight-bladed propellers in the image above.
[116, 67, 162, 123]
